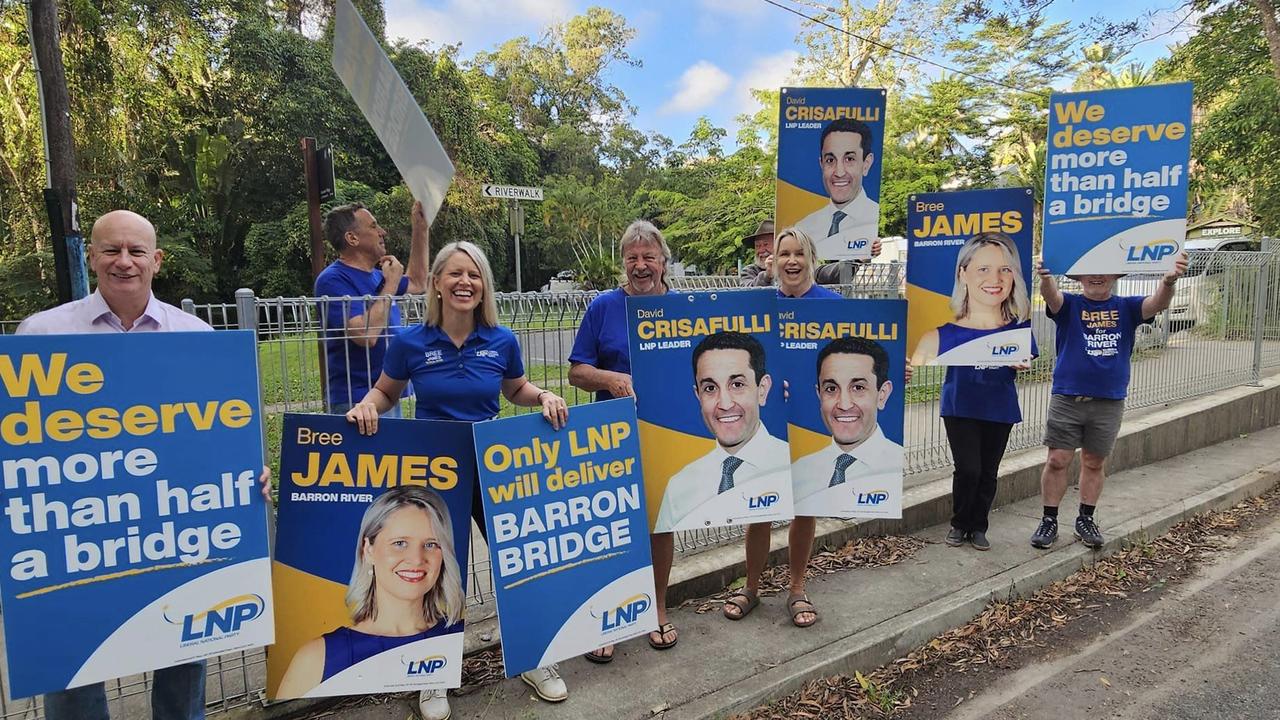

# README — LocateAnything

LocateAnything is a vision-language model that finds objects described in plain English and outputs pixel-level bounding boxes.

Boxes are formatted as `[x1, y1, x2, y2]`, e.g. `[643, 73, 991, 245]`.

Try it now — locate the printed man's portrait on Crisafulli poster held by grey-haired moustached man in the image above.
[654, 332, 791, 533]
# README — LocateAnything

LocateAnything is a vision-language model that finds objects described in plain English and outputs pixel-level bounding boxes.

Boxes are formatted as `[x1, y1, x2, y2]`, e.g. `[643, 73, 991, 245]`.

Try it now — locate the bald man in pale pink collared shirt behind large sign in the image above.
[17, 210, 271, 720]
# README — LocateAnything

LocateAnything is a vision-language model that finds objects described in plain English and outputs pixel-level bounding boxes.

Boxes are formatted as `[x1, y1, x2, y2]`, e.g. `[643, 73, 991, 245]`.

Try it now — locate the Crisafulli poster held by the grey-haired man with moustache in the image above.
[627, 290, 792, 533]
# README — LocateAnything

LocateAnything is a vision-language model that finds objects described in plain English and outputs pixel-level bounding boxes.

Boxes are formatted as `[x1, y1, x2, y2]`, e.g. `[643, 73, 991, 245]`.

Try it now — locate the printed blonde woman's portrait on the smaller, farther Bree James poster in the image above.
[911, 232, 1032, 365]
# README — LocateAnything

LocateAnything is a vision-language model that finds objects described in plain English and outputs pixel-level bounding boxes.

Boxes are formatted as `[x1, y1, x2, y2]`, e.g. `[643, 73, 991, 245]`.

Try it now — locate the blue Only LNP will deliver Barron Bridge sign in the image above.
[475, 398, 658, 678]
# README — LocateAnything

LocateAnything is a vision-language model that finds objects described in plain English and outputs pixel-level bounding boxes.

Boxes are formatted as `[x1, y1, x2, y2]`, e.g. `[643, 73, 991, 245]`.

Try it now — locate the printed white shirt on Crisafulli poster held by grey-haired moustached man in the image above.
[654, 424, 792, 533]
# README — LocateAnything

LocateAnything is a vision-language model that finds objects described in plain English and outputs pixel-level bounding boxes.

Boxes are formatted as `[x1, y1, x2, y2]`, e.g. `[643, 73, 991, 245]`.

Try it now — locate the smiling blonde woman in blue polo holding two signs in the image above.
[347, 242, 568, 720]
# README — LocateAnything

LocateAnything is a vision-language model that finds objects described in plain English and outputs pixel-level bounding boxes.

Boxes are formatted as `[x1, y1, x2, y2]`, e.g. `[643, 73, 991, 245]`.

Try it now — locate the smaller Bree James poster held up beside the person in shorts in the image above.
[906, 187, 1036, 365]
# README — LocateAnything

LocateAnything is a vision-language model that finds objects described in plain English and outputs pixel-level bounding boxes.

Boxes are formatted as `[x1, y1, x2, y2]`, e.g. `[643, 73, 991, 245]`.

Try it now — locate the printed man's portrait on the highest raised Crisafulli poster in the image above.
[796, 118, 879, 260]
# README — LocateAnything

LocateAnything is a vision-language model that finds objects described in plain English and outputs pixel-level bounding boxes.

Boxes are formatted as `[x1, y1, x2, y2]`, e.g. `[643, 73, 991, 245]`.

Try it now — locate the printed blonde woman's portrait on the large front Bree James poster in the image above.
[276, 486, 466, 698]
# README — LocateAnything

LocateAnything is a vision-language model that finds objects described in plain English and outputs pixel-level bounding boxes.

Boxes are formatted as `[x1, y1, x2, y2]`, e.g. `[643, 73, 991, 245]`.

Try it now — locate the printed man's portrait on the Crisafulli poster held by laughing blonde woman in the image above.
[791, 337, 902, 516]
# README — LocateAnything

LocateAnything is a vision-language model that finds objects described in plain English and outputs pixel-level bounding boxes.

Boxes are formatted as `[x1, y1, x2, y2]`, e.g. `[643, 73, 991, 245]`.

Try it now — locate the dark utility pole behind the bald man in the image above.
[27, 0, 88, 302]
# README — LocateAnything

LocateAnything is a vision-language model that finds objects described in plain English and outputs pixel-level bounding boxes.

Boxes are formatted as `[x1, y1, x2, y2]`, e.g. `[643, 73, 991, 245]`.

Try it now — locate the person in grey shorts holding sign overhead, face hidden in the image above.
[1032, 252, 1187, 548]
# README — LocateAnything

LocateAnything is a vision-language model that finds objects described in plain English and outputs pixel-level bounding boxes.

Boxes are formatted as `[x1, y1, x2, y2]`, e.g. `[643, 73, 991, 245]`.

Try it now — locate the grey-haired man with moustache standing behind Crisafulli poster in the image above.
[568, 220, 680, 664]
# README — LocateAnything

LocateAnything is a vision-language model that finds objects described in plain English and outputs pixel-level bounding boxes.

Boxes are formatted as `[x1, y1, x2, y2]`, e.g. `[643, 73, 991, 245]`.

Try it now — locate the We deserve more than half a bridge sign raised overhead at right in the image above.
[1043, 82, 1192, 275]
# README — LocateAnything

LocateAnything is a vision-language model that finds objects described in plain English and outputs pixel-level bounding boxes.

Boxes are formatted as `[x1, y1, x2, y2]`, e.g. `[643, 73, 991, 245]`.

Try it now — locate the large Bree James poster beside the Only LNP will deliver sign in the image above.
[266, 414, 475, 700]
